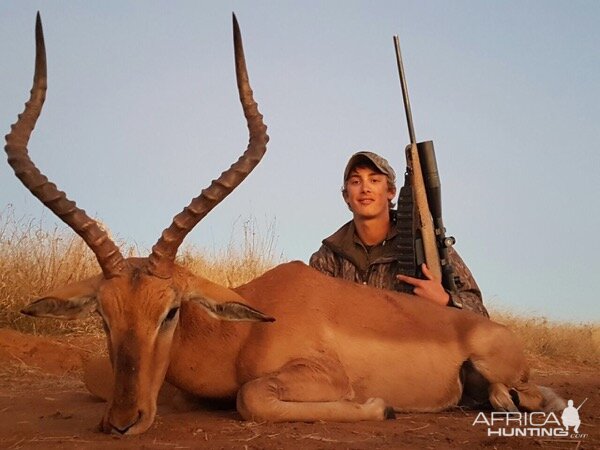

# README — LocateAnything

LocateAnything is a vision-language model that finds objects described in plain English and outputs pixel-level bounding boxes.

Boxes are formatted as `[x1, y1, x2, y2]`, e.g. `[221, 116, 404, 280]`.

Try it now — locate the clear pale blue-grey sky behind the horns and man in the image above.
[0, 0, 600, 323]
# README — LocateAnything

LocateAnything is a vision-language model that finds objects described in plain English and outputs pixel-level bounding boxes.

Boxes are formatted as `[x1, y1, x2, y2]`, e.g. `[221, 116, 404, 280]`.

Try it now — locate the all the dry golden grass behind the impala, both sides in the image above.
[0, 207, 600, 367]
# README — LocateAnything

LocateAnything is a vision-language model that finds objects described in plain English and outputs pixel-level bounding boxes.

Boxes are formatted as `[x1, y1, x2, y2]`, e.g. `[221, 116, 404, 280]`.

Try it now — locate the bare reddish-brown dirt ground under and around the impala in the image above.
[0, 329, 600, 450]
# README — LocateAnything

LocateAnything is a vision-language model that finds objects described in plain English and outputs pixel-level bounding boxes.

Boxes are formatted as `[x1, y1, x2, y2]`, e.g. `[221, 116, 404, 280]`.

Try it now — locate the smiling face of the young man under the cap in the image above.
[344, 166, 396, 219]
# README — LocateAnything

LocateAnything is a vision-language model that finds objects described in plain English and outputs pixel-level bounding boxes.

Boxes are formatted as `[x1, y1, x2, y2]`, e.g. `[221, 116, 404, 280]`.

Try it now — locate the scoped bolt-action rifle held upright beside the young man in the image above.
[394, 36, 456, 292]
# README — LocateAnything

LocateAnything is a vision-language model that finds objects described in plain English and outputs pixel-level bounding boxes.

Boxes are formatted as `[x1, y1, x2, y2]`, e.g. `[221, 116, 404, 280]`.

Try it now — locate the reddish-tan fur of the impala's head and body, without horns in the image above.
[70, 260, 564, 433]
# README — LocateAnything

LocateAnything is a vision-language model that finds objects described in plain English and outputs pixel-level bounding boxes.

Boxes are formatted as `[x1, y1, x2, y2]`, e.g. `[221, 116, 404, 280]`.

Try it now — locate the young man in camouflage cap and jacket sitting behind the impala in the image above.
[310, 152, 489, 317]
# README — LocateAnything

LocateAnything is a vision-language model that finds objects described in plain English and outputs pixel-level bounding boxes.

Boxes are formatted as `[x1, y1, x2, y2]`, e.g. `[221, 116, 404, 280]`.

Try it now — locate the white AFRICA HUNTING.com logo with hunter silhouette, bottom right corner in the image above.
[472, 398, 587, 439]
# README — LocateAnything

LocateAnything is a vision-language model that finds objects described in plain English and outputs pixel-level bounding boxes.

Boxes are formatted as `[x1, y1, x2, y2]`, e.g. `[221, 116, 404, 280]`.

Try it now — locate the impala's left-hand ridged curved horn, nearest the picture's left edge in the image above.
[4, 12, 125, 278]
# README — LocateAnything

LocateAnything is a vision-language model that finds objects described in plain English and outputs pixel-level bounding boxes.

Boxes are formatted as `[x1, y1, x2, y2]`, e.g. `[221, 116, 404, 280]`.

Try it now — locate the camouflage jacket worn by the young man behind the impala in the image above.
[309, 217, 489, 317]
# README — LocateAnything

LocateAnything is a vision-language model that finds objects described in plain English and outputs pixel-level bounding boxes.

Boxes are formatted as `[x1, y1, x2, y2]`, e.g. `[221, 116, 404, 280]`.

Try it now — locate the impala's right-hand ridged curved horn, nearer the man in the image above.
[148, 14, 269, 278]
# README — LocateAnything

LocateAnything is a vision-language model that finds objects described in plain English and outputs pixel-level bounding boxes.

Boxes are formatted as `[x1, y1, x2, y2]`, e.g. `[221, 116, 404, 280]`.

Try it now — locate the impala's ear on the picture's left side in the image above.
[21, 275, 104, 320]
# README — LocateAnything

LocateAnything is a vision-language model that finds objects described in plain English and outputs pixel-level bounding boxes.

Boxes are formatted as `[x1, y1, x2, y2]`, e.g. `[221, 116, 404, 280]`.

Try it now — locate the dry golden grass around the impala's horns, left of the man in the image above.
[0, 207, 282, 334]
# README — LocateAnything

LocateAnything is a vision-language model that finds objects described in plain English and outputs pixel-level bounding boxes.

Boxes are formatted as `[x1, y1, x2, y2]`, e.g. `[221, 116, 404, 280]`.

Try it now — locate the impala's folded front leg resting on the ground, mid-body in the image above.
[237, 359, 391, 422]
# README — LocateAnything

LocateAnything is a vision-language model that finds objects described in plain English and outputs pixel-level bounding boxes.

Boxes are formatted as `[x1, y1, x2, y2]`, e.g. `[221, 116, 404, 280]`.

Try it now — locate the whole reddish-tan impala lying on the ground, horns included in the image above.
[5, 14, 562, 434]
